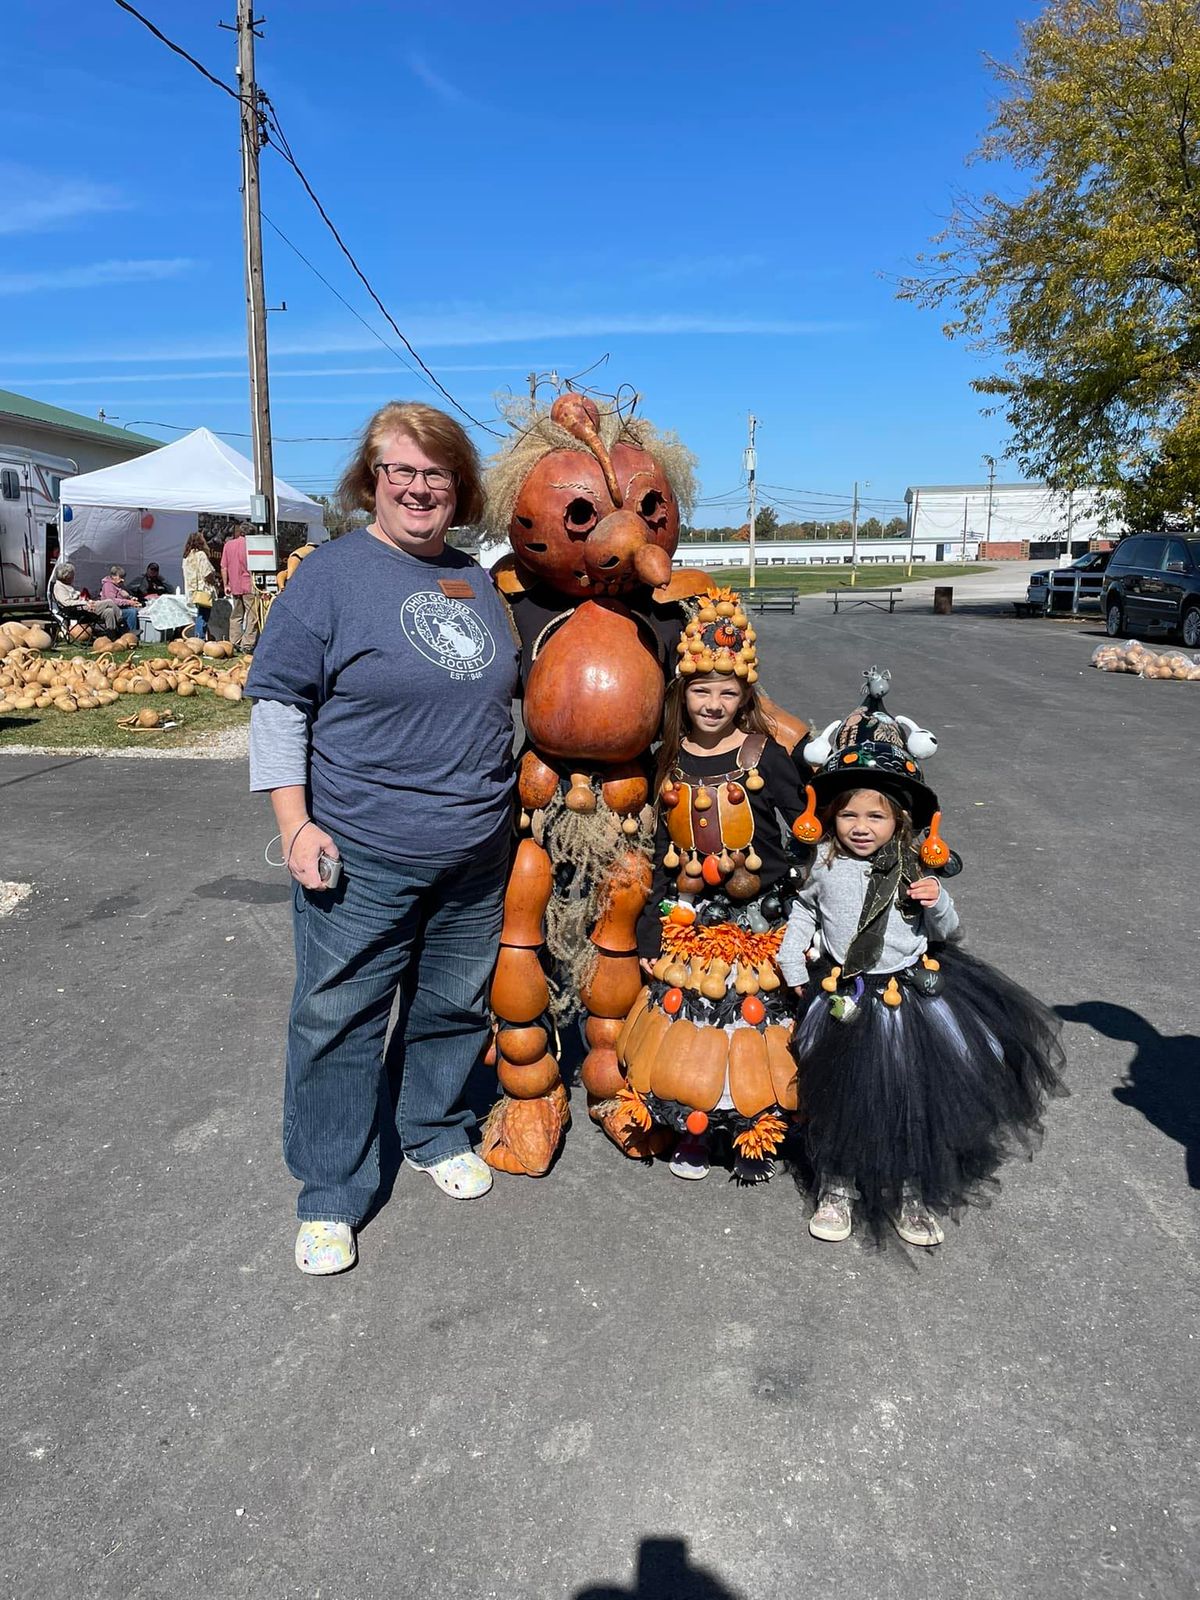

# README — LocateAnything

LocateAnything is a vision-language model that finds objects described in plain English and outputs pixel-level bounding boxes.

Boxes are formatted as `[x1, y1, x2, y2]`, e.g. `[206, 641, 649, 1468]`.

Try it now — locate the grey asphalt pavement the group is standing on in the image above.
[0, 595, 1200, 1600]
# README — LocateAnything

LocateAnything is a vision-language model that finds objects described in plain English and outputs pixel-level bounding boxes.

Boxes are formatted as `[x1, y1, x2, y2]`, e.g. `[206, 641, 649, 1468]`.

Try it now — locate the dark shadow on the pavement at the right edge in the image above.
[1054, 1000, 1200, 1189]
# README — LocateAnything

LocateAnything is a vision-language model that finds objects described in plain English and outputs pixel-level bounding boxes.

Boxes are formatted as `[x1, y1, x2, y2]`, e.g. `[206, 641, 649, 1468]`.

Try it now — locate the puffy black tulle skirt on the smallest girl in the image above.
[794, 947, 1066, 1226]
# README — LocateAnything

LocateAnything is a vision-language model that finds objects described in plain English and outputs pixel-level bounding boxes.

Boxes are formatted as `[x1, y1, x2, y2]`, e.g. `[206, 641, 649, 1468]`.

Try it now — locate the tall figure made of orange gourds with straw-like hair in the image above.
[482, 392, 752, 1176]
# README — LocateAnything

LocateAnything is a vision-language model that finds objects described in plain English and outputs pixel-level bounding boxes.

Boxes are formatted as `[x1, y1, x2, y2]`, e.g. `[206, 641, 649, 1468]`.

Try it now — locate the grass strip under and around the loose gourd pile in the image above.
[0, 645, 250, 750]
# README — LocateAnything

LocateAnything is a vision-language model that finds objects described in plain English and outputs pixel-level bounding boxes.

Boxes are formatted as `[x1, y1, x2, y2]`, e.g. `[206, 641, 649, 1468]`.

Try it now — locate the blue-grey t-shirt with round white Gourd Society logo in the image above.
[246, 530, 517, 866]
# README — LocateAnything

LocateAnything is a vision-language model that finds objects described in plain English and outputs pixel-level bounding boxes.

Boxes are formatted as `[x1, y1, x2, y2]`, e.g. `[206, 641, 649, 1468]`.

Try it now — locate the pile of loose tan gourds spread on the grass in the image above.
[0, 622, 250, 726]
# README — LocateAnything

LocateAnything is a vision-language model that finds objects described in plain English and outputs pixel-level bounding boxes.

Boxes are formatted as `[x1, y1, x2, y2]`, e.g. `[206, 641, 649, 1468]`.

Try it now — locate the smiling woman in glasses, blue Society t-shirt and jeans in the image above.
[246, 402, 517, 1274]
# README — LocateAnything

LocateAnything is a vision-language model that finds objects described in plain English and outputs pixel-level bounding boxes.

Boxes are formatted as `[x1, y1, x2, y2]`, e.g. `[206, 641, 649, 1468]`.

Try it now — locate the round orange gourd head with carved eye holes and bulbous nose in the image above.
[509, 443, 678, 600]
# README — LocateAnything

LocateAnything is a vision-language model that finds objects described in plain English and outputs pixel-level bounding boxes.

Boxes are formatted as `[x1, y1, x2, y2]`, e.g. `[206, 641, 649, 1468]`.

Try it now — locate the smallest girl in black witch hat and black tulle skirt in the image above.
[779, 667, 1062, 1246]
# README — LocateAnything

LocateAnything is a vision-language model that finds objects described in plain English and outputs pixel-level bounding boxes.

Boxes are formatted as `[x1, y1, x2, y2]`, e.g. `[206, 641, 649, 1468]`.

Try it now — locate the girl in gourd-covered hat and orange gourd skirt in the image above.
[616, 589, 816, 1182]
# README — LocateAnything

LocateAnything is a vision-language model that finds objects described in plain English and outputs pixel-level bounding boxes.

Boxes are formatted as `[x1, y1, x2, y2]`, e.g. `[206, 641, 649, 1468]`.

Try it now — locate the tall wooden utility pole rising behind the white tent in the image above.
[237, 0, 275, 556]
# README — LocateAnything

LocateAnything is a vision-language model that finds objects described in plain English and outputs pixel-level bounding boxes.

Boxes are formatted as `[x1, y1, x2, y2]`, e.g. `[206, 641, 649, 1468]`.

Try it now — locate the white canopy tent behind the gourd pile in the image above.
[59, 427, 325, 595]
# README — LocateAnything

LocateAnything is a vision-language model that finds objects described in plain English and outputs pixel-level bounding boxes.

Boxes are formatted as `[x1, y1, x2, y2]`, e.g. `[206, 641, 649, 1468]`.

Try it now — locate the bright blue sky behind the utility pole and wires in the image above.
[0, 0, 1037, 523]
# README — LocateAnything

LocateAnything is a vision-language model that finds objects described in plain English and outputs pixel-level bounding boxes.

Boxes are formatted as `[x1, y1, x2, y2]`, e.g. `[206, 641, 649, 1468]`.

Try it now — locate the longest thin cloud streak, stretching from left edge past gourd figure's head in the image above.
[8, 309, 866, 371]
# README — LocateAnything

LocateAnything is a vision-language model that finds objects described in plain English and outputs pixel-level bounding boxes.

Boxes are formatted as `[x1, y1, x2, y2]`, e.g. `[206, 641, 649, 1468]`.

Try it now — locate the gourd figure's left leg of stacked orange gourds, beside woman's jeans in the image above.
[480, 838, 571, 1178]
